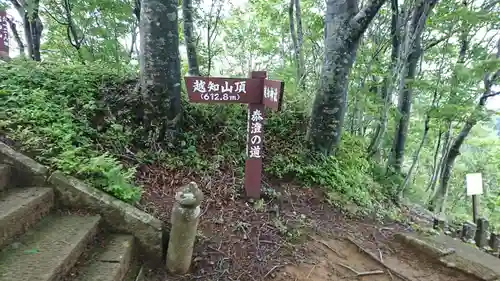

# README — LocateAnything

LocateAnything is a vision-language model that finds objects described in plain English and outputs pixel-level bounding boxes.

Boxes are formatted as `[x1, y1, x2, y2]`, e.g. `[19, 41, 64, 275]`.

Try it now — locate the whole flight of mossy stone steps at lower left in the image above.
[0, 149, 156, 281]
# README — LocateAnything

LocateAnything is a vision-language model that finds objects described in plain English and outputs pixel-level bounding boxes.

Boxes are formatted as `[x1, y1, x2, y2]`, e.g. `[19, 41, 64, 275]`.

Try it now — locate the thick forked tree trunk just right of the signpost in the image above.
[308, 0, 385, 155]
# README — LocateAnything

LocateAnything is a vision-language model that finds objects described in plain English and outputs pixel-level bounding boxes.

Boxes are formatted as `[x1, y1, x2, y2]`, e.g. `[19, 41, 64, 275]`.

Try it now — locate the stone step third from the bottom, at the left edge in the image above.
[0, 187, 54, 249]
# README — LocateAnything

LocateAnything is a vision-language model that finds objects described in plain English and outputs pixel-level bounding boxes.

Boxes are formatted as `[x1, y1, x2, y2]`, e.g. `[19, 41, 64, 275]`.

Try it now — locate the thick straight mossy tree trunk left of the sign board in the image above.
[140, 0, 181, 142]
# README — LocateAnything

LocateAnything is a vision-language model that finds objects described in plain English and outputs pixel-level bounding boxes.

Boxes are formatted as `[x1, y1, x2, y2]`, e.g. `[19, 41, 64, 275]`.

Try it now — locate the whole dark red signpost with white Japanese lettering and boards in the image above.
[184, 71, 284, 199]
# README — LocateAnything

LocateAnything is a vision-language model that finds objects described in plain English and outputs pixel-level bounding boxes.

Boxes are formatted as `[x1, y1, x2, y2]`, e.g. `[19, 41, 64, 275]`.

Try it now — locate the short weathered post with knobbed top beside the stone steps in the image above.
[167, 182, 203, 274]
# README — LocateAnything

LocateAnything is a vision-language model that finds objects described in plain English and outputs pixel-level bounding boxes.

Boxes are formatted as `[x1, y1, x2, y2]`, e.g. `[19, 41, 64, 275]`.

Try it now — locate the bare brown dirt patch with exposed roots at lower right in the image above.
[277, 238, 479, 281]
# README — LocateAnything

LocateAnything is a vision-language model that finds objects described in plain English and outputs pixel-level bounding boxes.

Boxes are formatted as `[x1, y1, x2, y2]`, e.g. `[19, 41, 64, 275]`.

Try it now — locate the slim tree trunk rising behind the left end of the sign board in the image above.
[182, 0, 200, 76]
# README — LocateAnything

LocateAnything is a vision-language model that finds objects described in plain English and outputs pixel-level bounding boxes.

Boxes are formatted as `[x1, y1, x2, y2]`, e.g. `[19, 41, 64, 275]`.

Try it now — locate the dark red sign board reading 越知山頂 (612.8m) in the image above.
[184, 76, 263, 103]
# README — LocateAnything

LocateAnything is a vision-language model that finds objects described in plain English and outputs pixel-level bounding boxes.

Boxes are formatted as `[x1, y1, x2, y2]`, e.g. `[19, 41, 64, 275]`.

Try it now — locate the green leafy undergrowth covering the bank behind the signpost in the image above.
[0, 61, 393, 213]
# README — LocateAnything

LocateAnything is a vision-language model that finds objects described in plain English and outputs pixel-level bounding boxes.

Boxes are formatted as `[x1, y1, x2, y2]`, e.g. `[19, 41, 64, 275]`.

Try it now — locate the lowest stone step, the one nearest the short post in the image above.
[73, 234, 136, 281]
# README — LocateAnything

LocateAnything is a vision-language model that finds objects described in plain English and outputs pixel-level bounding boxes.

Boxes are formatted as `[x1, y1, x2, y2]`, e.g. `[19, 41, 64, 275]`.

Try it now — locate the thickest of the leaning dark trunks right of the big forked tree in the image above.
[389, 0, 437, 173]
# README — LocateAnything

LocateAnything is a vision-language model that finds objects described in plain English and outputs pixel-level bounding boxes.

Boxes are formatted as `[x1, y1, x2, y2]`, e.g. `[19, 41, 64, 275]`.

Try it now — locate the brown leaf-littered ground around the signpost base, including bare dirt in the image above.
[133, 166, 478, 281]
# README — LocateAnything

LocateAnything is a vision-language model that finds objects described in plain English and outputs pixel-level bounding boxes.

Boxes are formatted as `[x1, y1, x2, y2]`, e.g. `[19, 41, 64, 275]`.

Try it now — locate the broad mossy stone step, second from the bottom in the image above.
[0, 212, 101, 281]
